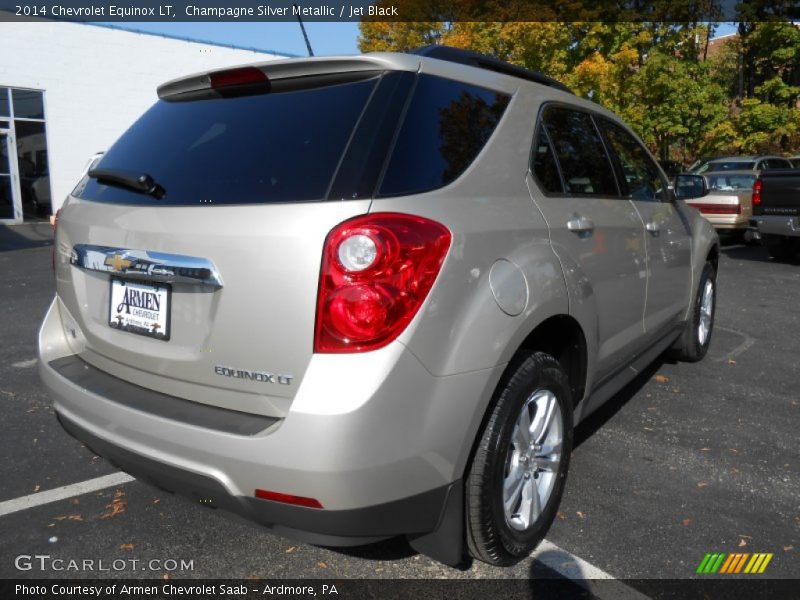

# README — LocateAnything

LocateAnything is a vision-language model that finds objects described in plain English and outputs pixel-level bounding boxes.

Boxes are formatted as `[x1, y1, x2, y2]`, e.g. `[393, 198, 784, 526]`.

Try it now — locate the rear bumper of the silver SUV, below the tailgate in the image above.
[39, 299, 502, 546]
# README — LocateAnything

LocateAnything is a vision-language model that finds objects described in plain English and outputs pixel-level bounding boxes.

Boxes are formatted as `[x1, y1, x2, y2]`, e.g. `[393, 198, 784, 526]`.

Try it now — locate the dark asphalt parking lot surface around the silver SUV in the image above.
[0, 224, 800, 579]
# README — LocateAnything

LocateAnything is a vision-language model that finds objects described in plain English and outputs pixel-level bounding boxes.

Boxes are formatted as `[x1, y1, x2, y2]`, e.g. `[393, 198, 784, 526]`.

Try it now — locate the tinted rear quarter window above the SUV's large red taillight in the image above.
[378, 75, 510, 196]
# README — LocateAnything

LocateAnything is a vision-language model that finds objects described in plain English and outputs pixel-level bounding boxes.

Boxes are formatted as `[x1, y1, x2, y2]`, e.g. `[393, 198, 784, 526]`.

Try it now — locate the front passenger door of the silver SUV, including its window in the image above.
[597, 117, 692, 338]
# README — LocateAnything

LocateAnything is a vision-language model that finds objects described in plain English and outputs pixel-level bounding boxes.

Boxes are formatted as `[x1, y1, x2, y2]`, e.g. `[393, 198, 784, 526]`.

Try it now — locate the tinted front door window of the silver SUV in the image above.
[598, 117, 665, 202]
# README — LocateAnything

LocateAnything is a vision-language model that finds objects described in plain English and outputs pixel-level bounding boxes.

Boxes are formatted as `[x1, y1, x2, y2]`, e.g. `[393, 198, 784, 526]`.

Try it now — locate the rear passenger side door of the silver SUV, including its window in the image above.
[530, 104, 647, 379]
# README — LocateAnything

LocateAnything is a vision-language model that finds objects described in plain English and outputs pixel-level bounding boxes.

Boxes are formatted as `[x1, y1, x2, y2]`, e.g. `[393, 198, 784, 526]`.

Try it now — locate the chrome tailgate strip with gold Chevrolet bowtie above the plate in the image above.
[69, 244, 222, 288]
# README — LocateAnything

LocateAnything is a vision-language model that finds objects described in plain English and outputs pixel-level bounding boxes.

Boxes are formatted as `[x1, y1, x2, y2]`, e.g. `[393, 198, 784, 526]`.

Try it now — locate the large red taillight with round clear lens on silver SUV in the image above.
[314, 213, 452, 352]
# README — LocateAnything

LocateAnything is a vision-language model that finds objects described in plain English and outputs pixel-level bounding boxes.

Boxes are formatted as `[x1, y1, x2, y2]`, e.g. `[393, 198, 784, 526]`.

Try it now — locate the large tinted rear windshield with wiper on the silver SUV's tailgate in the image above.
[73, 76, 379, 205]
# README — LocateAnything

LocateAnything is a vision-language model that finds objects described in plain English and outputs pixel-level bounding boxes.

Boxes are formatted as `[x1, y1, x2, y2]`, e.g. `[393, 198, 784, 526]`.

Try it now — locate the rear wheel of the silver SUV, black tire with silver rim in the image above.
[465, 352, 572, 566]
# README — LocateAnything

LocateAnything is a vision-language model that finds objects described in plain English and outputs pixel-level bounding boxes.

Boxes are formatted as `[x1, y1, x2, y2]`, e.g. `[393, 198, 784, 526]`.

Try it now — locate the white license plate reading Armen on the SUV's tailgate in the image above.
[108, 278, 172, 341]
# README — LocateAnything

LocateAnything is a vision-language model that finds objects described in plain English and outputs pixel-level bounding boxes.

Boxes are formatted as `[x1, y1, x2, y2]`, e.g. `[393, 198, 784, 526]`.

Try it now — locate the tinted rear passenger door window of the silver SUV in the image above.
[542, 106, 619, 196]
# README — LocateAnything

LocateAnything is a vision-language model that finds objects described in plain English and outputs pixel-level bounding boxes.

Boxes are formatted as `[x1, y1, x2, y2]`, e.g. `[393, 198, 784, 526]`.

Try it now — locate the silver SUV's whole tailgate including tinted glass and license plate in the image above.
[56, 72, 413, 416]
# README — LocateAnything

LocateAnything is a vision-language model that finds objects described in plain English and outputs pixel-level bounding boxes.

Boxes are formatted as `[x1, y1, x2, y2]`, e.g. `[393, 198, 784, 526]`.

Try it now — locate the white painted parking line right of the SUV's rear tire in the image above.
[531, 540, 650, 600]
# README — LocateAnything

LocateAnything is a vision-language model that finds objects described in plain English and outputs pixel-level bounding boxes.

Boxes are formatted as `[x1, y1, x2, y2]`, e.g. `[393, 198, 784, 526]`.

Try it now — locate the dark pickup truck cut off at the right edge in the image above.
[750, 169, 800, 260]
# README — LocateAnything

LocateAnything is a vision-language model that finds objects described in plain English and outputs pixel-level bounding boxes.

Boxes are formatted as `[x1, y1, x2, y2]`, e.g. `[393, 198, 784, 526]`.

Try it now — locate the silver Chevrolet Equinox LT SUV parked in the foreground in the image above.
[39, 46, 719, 565]
